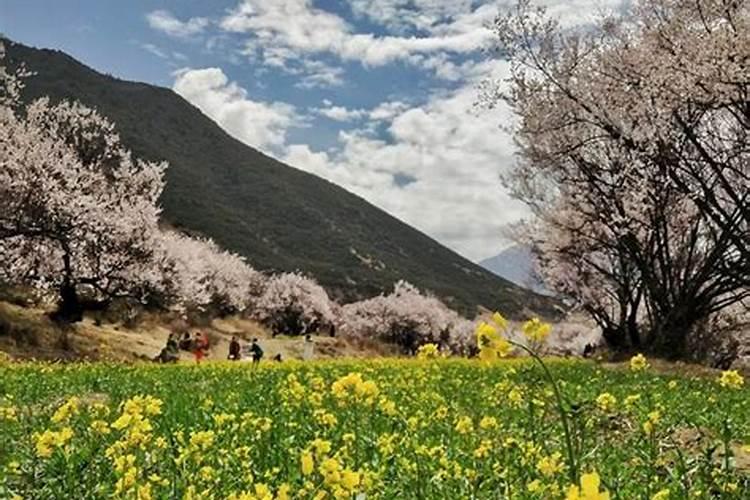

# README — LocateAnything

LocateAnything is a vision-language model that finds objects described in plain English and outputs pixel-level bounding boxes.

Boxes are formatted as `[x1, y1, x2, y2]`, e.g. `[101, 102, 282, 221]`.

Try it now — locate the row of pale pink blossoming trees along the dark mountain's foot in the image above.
[0, 45, 471, 351]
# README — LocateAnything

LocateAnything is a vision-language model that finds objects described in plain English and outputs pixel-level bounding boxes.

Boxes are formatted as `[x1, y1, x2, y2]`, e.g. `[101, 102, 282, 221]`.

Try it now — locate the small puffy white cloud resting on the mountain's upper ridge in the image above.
[173, 68, 302, 153]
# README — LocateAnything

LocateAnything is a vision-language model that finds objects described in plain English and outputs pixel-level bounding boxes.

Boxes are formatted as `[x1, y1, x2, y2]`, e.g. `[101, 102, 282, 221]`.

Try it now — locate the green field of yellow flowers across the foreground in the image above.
[0, 358, 750, 500]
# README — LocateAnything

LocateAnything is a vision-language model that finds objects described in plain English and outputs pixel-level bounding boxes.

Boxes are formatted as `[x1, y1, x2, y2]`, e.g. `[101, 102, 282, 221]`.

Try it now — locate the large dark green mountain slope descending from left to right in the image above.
[5, 41, 553, 315]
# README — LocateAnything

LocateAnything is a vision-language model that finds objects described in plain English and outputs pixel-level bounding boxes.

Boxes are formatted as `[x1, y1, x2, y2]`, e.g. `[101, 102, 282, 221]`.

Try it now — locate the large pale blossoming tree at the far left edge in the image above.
[0, 48, 165, 321]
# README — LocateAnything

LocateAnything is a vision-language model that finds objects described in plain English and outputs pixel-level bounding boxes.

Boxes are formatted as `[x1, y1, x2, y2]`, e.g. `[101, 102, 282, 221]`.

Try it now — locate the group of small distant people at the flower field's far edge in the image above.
[154, 332, 314, 364]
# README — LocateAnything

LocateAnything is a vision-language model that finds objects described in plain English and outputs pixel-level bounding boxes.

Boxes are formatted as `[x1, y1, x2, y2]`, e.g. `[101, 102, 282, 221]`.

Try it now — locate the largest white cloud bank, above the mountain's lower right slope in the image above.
[283, 63, 528, 259]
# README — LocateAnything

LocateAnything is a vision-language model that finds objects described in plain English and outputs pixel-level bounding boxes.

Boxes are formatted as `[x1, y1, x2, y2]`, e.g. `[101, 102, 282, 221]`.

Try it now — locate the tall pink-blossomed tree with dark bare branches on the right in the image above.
[485, 0, 750, 357]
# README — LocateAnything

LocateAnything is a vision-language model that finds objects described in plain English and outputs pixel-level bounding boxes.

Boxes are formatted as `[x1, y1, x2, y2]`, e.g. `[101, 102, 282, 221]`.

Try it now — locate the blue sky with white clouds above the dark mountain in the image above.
[0, 0, 627, 261]
